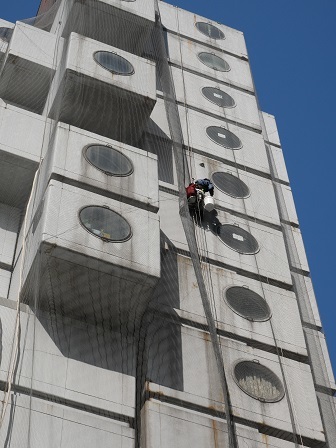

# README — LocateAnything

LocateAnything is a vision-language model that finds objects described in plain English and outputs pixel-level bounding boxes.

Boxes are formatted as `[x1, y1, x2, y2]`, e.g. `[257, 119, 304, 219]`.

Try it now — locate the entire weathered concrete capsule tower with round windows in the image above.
[0, 0, 336, 448]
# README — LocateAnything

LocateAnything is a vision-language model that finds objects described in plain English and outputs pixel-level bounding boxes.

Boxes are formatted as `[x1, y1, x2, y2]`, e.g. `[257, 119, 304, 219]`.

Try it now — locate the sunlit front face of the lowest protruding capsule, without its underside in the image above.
[28, 181, 160, 276]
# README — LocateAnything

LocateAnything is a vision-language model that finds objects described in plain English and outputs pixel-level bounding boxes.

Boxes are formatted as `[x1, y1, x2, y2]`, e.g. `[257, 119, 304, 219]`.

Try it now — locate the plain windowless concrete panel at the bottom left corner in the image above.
[0, 394, 134, 448]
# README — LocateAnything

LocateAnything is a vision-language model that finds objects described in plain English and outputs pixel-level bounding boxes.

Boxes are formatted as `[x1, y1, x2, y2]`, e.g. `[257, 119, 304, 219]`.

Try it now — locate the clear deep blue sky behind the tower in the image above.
[0, 0, 336, 371]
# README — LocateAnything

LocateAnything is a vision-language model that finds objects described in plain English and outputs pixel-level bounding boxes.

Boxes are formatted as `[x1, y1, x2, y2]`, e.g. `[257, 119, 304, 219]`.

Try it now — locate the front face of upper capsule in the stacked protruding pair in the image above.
[44, 123, 159, 210]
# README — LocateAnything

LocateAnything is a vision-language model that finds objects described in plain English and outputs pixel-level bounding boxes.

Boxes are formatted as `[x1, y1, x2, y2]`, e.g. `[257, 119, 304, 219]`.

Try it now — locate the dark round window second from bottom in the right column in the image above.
[225, 286, 271, 322]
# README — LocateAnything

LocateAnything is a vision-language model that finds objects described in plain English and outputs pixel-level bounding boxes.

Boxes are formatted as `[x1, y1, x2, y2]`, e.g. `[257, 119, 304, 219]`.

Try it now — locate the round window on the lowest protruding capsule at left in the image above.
[79, 205, 132, 242]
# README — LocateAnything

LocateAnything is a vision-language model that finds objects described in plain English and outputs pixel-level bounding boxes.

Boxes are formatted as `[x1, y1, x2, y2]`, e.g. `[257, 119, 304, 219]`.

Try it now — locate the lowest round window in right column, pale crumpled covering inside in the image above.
[234, 361, 285, 403]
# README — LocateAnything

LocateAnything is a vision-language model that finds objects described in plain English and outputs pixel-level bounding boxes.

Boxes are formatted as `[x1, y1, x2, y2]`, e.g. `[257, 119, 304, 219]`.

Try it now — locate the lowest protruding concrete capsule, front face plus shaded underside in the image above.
[23, 181, 160, 325]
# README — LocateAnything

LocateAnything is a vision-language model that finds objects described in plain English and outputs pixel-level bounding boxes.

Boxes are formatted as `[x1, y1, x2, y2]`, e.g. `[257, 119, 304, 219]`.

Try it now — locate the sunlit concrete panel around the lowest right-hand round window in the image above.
[149, 327, 325, 441]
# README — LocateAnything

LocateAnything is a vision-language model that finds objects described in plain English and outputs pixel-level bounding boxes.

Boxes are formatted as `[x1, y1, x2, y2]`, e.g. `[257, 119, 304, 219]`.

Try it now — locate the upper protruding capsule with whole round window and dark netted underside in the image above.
[47, 33, 156, 144]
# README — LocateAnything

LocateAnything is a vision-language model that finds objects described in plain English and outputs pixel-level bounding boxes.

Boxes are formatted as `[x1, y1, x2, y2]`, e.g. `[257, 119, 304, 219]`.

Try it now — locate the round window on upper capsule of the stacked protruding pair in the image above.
[84, 145, 133, 176]
